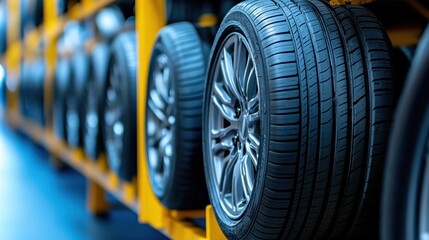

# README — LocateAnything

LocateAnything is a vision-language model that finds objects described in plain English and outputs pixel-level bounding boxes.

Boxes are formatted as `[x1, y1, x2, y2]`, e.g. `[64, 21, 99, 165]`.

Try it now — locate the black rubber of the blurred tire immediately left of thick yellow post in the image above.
[103, 32, 137, 181]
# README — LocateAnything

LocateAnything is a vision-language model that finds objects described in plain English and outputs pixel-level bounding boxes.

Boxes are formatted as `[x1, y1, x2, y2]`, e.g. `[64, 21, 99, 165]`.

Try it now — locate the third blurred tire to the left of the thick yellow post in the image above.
[66, 50, 90, 148]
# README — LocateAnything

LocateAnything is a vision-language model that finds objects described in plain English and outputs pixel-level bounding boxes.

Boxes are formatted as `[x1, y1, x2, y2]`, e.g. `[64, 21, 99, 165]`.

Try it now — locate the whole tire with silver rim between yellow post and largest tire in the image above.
[145, 22, 209, 209]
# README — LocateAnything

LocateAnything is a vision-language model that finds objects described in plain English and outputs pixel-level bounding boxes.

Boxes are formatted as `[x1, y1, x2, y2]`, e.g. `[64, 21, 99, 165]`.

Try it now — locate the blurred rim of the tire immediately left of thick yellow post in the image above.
[104, 65, 125, 171]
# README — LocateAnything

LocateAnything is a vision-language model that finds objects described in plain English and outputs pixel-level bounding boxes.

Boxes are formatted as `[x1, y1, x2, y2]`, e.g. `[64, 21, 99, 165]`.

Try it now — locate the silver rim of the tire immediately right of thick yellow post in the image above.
[146, 53, 176, 195]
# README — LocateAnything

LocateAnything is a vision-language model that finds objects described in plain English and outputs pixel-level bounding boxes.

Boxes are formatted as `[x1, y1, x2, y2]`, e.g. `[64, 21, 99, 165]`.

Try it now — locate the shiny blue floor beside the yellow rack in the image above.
[0, 116, 166, 240]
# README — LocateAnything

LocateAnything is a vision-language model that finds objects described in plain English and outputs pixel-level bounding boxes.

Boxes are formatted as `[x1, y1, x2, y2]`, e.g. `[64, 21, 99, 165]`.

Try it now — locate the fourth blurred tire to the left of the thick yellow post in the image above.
[52, 58, 71, 140]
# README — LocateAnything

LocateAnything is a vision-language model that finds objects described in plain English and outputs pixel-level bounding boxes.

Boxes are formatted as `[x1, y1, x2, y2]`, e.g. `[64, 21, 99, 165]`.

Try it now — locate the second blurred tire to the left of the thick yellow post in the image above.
[83, 43, 110, 160]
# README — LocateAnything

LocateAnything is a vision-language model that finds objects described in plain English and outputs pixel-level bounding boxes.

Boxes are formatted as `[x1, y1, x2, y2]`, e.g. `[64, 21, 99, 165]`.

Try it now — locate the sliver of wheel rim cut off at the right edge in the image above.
[417, 141, 429, 240]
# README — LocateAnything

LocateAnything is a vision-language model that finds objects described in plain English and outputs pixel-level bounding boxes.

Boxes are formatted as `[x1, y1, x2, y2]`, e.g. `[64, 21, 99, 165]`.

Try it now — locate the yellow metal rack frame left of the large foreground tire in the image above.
[2, 0, 225, 239]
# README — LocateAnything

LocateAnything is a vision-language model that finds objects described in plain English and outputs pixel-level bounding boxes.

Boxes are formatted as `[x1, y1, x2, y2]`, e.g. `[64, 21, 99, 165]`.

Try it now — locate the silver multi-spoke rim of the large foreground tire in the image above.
[209, 32, 261, 219]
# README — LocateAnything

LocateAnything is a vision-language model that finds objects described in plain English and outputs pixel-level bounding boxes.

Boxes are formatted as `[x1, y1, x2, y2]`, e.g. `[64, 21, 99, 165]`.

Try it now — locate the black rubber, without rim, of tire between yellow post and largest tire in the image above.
[145, 22, 210, 209]
